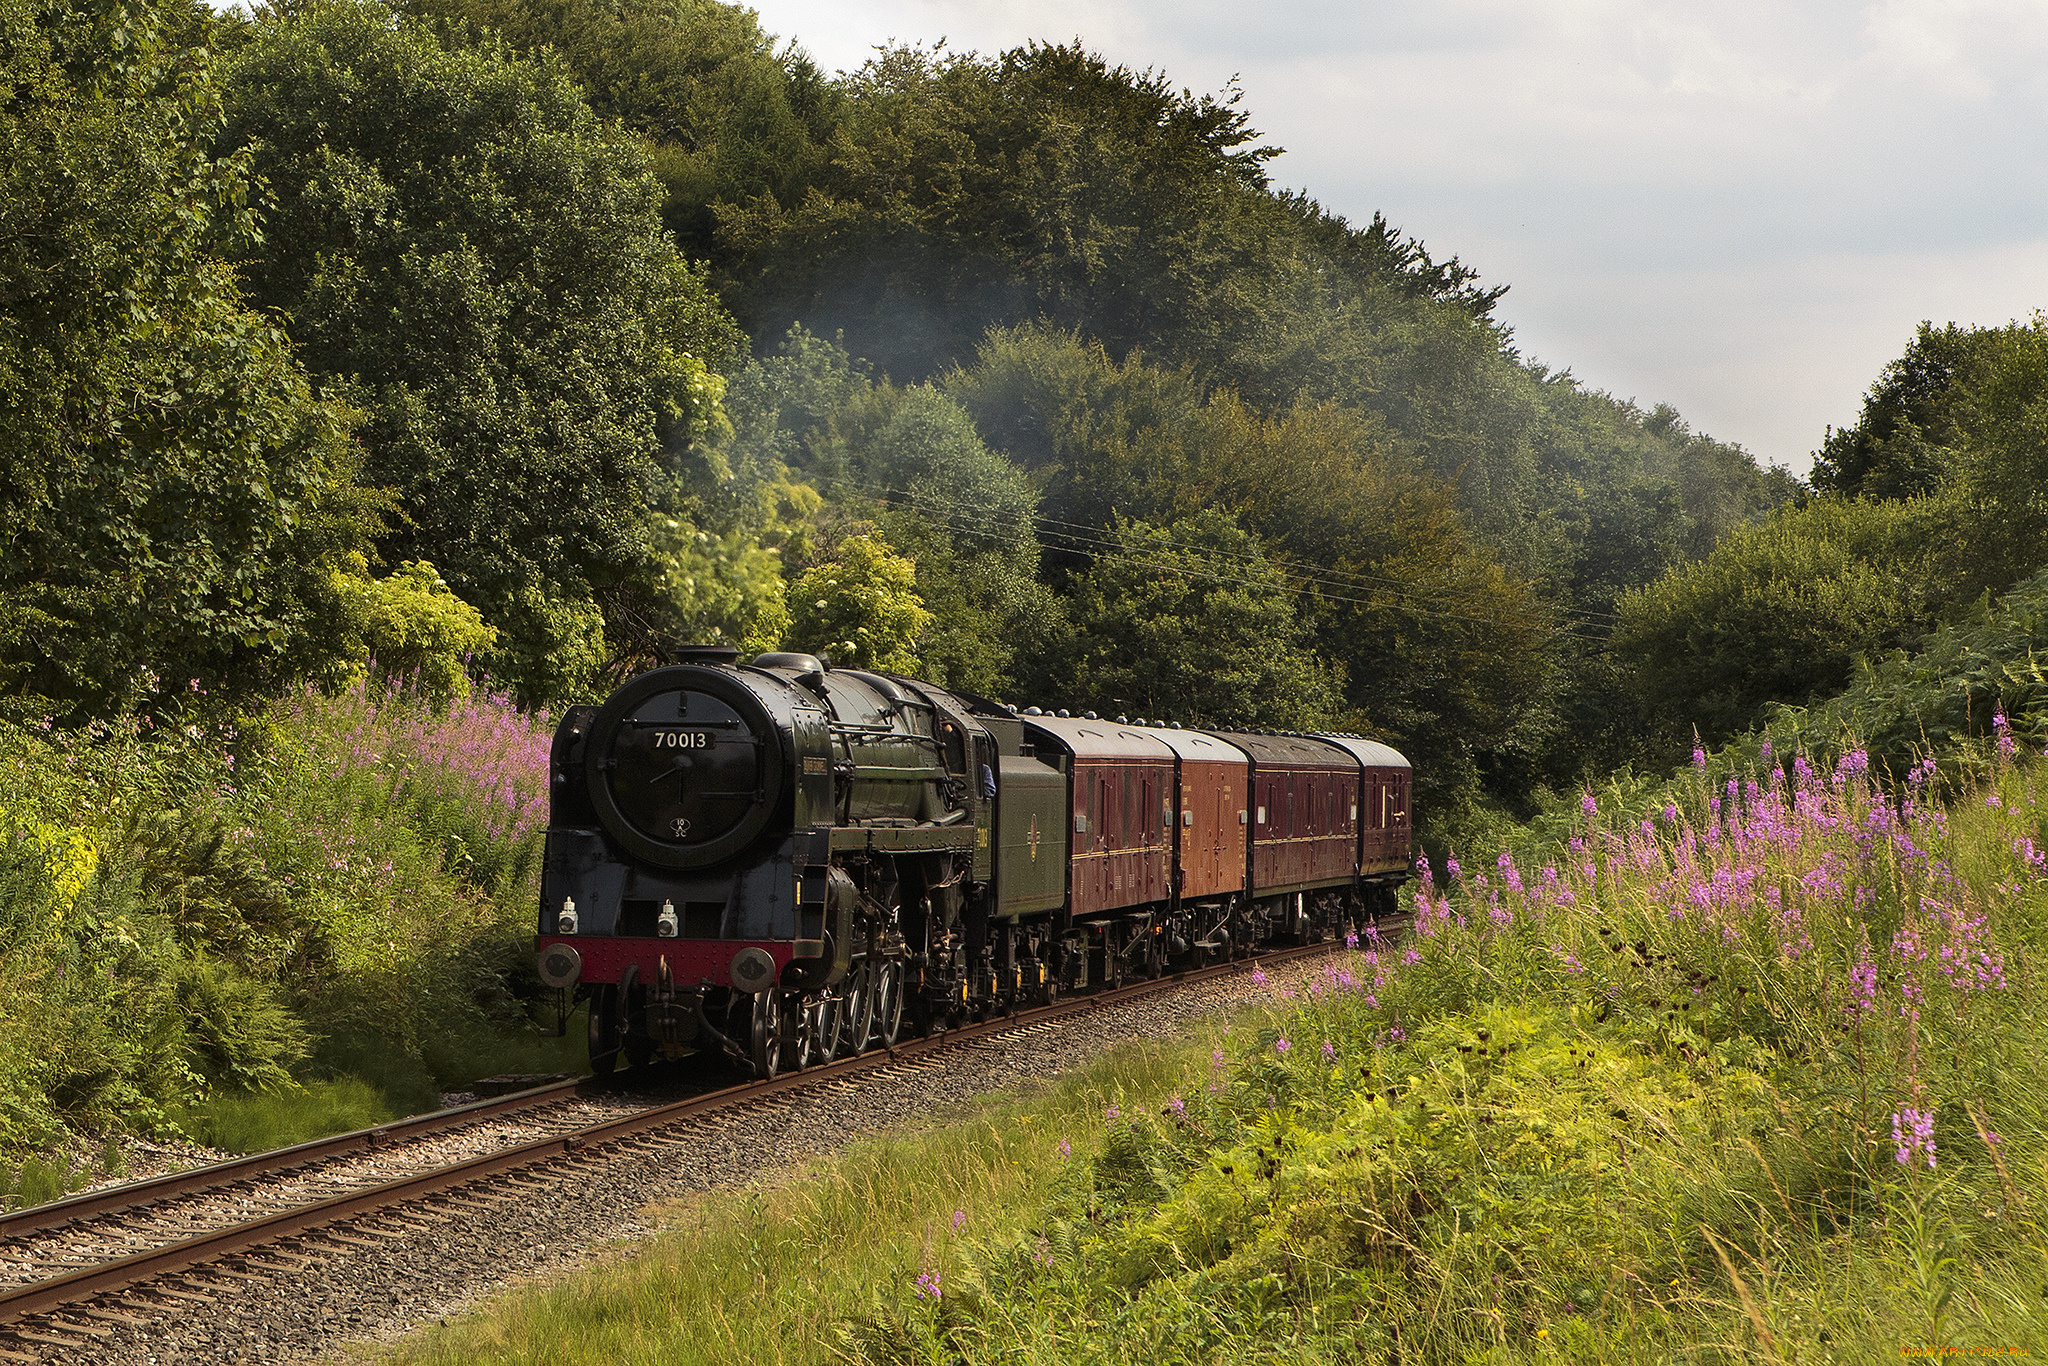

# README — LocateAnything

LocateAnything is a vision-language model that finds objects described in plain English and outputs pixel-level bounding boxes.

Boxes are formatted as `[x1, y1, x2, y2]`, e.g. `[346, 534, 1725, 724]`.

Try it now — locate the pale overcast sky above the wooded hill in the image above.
[756, 0, 2048, 473]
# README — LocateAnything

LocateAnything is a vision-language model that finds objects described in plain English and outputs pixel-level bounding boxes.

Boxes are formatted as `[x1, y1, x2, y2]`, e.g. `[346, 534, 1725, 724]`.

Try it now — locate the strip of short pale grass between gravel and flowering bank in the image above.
[370, 1032, 1266, 1366]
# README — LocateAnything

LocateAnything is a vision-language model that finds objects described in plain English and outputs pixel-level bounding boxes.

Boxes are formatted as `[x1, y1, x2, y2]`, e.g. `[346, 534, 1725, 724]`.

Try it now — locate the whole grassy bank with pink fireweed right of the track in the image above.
[385, 743, 2048, 1366]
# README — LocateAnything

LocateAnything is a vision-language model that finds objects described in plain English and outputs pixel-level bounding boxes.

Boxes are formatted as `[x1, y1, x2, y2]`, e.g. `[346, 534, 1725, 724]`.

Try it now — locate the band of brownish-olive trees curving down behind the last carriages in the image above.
[946, 326, 1554, 811]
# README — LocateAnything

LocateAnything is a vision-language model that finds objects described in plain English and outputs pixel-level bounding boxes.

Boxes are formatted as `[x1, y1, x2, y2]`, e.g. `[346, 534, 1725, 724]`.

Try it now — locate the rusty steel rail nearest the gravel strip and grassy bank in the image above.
[0, 942, 1341, 1327]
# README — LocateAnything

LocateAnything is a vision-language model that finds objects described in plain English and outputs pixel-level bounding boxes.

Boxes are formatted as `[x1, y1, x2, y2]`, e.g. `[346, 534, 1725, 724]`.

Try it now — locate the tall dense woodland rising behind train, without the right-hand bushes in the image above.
[0, 0, 1826, 835]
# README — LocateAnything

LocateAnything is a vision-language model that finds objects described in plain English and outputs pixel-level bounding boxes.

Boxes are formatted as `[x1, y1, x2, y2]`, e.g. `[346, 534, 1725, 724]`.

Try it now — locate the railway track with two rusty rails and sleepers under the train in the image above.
[0, 944, 1359, 1362]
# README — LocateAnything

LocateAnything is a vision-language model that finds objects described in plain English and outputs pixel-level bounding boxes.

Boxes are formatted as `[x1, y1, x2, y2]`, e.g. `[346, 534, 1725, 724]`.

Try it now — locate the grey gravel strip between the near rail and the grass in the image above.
[48, 954, 1351, 1366]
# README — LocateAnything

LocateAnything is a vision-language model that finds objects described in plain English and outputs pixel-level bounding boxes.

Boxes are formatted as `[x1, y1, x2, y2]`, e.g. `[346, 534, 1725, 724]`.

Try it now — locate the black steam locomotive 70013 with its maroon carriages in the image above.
[539, 647, 1411, 1077]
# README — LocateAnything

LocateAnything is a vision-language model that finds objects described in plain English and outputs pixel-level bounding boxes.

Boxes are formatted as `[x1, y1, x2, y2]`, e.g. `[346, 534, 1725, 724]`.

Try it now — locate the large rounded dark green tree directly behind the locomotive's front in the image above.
[221, 0, 737, 698]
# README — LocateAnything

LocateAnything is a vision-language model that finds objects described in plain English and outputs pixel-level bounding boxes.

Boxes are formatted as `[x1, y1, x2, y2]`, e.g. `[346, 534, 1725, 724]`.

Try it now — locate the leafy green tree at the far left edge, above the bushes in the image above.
[0, 0, 375, 713]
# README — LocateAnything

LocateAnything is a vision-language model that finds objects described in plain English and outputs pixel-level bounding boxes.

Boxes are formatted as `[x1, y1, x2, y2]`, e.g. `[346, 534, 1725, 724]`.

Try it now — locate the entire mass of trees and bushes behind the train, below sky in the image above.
[0, 0, 2048, 1178]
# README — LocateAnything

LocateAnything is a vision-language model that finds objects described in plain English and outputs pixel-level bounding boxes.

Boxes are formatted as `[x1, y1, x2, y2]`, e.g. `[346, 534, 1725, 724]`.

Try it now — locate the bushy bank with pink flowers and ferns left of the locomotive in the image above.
[0, 678, 559, 1149]
